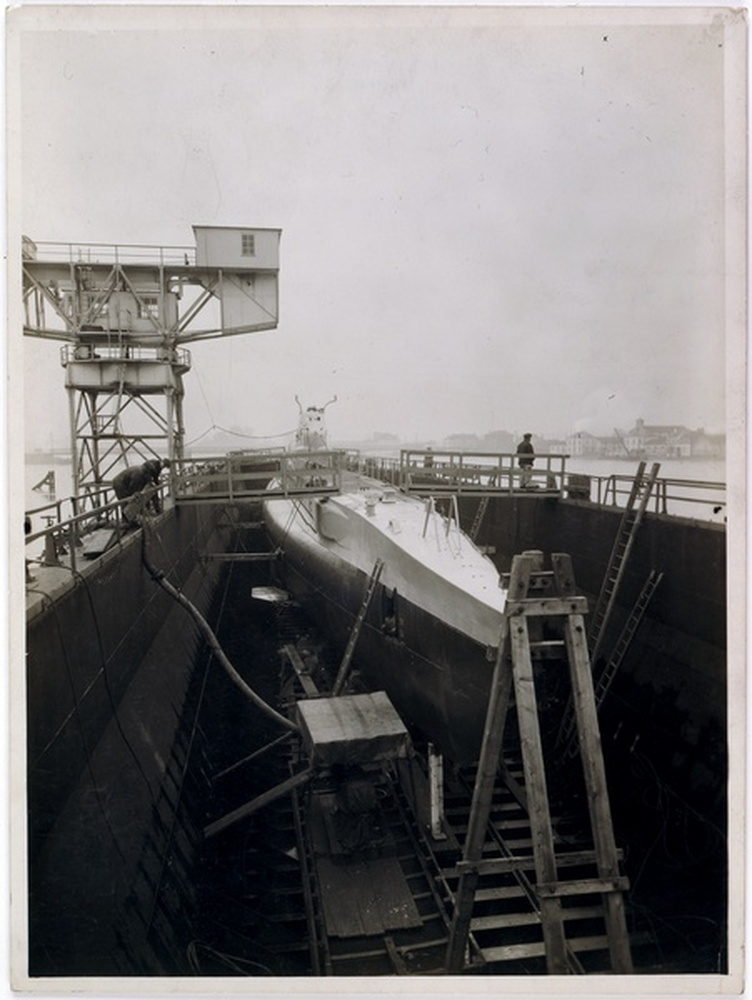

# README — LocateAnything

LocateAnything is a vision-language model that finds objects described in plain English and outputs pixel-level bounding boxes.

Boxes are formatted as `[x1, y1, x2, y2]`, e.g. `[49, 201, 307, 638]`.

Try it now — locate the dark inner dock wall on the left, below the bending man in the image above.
[27, 507, 229, 976]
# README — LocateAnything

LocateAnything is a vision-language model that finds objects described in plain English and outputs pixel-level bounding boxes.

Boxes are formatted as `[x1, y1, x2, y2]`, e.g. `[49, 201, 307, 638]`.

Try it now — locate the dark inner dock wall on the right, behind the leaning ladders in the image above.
[468, 497, 727, 823]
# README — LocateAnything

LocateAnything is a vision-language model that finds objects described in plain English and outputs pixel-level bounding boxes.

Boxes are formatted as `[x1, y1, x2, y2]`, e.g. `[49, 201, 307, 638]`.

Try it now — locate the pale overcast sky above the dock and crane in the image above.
[10, 7, 744, 446]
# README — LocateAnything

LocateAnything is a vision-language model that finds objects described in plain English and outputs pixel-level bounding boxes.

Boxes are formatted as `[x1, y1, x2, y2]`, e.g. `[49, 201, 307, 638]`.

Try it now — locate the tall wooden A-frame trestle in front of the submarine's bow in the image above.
[445, 552, 632, 975]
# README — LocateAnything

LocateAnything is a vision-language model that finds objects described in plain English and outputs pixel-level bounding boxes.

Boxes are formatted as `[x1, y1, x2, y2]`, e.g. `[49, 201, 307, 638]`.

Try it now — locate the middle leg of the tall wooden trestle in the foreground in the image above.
[509, 617, 568, 975]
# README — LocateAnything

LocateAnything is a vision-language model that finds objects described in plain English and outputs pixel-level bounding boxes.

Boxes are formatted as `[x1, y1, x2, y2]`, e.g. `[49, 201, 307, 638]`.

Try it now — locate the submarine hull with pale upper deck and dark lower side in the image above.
[265, 488, 504, 763]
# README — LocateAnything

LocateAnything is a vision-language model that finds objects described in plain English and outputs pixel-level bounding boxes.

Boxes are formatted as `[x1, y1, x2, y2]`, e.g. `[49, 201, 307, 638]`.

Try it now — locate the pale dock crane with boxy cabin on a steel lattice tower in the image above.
[22, 226, 281, 496]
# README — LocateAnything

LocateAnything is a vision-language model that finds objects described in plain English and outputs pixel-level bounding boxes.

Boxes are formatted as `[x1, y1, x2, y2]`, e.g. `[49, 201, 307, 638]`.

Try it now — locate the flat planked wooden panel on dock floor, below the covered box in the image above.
[316, 857, 423, 937]
